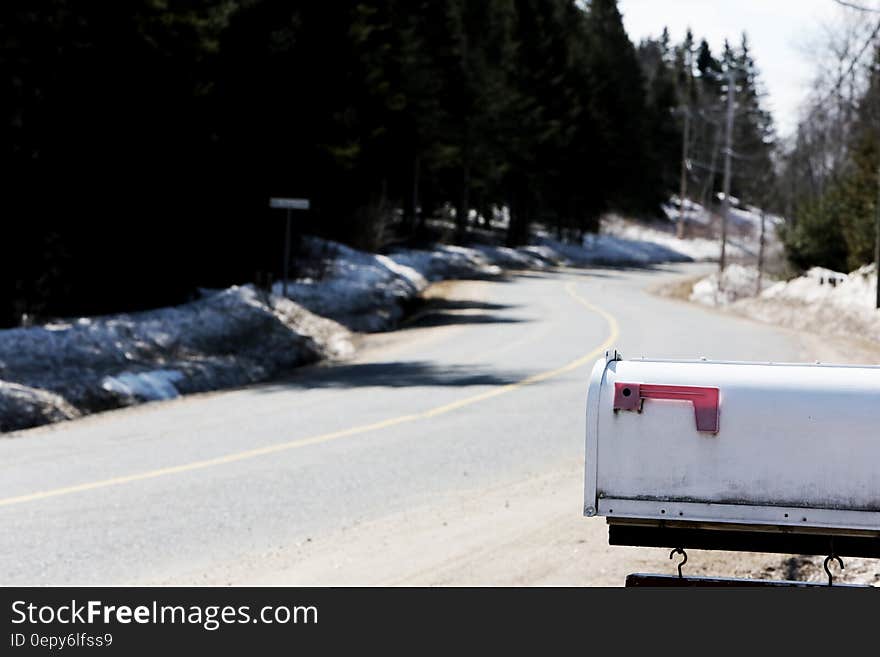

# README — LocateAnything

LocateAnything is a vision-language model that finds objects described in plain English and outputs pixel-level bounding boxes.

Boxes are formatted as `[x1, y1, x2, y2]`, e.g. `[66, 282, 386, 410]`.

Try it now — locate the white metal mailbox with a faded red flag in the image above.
[584, 352, 880, 556]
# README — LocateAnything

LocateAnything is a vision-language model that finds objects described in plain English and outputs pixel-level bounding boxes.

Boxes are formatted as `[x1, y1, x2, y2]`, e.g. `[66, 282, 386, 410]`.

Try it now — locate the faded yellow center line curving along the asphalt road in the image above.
[0, 283, 619, 507]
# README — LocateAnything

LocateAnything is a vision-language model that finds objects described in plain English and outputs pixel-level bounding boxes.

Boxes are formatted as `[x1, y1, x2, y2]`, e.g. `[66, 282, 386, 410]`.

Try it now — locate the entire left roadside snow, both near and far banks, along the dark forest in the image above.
[0, 221, 752, 431]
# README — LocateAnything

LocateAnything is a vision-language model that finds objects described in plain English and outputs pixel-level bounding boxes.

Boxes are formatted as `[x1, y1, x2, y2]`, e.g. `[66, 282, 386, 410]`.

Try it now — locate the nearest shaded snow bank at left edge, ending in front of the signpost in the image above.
[0, 286, 353, 431]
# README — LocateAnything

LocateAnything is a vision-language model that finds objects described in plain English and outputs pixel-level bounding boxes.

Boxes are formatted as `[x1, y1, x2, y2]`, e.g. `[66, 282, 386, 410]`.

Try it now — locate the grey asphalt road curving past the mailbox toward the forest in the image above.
[0, 265, 802, 585]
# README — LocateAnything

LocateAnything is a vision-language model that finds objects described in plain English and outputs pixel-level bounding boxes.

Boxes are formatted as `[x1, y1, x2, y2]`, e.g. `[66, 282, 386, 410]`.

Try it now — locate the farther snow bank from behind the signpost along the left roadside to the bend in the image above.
[272, 221, 736, 332]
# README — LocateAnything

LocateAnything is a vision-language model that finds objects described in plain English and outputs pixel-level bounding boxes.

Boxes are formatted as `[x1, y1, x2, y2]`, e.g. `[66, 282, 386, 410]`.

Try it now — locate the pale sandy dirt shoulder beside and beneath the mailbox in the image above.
[167, 461, 880, 586]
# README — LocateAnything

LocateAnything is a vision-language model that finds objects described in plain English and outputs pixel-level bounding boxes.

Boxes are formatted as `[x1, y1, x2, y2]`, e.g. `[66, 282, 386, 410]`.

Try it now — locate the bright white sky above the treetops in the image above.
[618, 0, 844, 137]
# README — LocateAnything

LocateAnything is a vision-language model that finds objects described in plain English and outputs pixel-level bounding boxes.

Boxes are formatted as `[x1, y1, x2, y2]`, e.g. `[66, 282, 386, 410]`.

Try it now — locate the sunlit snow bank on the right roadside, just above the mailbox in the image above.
[732, 265, 880, 341]
